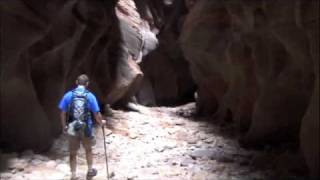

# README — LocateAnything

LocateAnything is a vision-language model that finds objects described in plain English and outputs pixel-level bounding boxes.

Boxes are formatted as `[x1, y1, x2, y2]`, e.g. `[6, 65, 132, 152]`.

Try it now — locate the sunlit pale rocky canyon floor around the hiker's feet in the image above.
[1, 104, 271, 180]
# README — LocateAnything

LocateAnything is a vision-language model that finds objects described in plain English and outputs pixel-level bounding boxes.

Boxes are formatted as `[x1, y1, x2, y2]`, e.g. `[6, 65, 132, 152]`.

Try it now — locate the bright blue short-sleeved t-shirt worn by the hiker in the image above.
[59, 86, 100, 137]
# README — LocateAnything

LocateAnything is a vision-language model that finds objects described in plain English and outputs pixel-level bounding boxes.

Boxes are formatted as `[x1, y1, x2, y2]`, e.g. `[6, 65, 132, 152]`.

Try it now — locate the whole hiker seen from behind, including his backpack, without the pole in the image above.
[59, 74, 106, 179]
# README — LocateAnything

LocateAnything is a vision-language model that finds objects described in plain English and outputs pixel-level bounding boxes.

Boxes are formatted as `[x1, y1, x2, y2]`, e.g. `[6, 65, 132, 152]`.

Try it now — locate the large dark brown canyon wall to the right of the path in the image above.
[180, 0, 319, 174]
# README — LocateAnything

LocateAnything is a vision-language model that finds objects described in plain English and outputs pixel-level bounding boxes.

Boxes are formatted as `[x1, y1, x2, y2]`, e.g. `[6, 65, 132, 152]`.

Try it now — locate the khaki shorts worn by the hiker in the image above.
[68, 135, 94, 152]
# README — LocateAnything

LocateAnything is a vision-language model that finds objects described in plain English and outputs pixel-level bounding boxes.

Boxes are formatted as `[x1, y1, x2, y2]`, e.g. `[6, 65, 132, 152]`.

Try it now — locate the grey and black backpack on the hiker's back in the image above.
[68, 89, 91, 123]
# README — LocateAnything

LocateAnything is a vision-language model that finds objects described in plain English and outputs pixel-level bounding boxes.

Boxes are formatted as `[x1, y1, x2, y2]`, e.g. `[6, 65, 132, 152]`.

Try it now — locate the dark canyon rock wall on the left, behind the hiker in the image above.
[0, 0, 141, 151]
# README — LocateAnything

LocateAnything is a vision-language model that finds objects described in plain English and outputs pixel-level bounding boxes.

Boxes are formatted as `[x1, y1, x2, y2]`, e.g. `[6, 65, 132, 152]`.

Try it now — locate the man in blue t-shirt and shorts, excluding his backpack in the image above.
[59, 74, 106, 179]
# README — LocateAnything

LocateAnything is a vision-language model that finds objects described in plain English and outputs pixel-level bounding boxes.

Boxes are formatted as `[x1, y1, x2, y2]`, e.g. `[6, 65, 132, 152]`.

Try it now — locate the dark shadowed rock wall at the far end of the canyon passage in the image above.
[135, 0, 196, 106]
